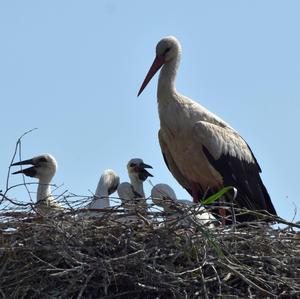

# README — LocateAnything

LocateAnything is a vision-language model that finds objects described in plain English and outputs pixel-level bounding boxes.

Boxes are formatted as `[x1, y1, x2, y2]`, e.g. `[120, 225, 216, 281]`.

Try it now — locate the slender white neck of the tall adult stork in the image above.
[157, 55, 180, 102]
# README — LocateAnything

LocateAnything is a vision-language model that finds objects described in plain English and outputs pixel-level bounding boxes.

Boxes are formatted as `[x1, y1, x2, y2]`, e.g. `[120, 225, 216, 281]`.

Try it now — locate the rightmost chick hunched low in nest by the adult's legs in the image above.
[151, 184, 217, 228]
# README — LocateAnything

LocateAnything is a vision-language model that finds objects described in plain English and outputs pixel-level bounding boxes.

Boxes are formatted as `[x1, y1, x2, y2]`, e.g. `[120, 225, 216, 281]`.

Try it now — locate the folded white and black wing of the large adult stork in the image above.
[193, 121, 276, 215]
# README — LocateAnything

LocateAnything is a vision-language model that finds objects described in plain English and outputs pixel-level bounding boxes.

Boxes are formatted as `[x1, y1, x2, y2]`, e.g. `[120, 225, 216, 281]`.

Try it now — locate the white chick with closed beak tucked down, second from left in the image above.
[88, 169, 120, 209]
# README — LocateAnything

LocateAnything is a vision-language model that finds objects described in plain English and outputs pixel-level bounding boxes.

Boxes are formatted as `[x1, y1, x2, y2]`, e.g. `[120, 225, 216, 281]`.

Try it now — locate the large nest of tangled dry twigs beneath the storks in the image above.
[0, 199, 300, 299]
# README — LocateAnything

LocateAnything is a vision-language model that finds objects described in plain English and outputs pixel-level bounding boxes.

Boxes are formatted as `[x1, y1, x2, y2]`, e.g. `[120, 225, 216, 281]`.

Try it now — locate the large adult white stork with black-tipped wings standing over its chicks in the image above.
[138, 36, 276, 221]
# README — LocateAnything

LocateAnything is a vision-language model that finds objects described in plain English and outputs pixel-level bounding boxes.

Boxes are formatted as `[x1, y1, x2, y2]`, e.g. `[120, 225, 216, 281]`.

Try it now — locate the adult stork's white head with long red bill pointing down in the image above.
[138, 36, 181, 96]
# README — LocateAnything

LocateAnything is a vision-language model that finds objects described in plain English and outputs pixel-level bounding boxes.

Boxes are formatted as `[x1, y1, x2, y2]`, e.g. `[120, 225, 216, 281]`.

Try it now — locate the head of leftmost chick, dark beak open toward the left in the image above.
[12, 154, 57, 181]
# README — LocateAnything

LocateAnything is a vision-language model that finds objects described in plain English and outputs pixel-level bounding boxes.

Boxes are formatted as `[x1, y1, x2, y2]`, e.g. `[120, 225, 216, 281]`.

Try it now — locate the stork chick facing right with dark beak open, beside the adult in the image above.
[117, 158, 153, 222]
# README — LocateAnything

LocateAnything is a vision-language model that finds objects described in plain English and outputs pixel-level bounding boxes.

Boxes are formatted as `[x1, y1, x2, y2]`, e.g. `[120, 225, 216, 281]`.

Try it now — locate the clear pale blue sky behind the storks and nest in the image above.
[0, 0, 300, 220]
